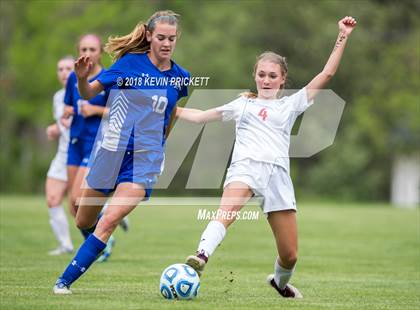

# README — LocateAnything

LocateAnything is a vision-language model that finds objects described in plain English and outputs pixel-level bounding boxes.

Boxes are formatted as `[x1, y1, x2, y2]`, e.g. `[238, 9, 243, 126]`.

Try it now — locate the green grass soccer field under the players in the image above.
[0, 196, 420, 310]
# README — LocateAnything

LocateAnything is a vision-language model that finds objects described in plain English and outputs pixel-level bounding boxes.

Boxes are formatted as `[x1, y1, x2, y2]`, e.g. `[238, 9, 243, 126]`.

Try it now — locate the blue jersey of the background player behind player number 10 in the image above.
[64, 69, 108, 141]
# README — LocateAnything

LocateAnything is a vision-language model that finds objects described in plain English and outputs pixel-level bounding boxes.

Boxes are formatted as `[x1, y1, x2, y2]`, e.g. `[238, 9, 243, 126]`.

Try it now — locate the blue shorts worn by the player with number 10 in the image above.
[86, 148, 164, 199]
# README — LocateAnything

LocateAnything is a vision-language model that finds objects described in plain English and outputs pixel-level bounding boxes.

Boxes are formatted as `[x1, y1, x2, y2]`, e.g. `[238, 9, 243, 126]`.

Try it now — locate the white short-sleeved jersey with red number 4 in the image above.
[216, 88, 312, 171]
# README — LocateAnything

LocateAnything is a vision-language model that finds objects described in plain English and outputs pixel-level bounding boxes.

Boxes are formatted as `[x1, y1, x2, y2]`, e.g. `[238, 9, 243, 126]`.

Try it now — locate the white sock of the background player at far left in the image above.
[48, 206, 73, 250]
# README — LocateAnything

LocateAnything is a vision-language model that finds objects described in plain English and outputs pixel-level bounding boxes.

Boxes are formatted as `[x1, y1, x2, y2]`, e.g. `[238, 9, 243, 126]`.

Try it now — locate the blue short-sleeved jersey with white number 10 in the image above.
[97, 53, 190, 151]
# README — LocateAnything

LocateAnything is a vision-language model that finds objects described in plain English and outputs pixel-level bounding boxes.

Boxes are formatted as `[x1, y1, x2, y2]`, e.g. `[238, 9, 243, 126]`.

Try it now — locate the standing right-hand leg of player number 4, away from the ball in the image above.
[267, 210, 303, 298]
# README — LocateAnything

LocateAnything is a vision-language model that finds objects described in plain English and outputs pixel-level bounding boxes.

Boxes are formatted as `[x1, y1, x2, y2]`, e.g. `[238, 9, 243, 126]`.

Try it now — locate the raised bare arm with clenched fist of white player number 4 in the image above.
[306, 16, 357, 101]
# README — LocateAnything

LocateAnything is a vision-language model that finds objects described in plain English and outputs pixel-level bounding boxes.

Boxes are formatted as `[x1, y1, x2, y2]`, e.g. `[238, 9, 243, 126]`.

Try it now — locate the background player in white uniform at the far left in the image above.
[45, 56, 74, 255]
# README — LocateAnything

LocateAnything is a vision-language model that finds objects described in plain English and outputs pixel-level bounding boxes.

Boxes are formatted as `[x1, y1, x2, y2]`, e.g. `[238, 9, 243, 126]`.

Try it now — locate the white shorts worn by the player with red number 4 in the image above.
[224, 159, 296, 214]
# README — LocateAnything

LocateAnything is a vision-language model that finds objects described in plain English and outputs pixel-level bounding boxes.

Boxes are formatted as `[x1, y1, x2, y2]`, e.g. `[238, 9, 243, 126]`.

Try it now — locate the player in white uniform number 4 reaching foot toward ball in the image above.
[176, 16, 356, 298]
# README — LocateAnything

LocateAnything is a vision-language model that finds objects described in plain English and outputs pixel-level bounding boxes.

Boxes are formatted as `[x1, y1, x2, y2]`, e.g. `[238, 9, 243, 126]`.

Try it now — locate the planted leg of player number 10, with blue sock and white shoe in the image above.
[53, 183, 146, 294]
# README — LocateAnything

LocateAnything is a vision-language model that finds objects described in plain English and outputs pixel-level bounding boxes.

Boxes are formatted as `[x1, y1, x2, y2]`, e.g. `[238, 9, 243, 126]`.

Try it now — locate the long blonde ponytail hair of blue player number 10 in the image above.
[105, 10, 179, 61]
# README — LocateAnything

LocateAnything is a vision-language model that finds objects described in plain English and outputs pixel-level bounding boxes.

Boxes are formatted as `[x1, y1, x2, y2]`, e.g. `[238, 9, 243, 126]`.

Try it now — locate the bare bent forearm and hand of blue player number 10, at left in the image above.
[74, 56, 104, 100]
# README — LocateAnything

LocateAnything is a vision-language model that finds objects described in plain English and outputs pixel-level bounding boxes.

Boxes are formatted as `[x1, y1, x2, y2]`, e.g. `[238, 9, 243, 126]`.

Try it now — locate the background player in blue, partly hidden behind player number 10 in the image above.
[63, 33, 114, 261]
